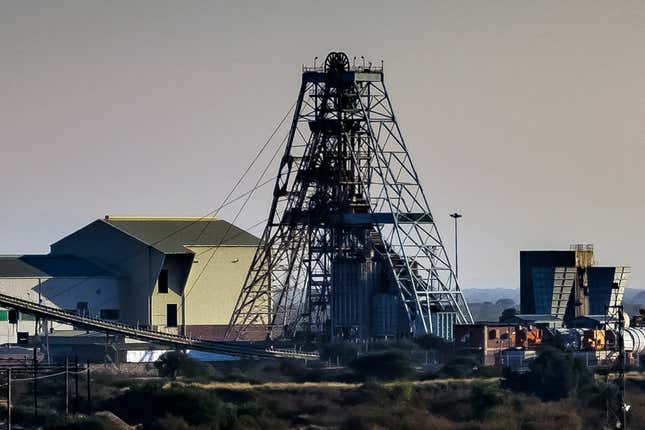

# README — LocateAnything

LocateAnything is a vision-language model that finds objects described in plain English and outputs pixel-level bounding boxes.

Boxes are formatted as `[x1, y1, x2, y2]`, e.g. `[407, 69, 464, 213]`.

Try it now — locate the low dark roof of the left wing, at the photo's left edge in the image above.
[0, 255, 113, 278]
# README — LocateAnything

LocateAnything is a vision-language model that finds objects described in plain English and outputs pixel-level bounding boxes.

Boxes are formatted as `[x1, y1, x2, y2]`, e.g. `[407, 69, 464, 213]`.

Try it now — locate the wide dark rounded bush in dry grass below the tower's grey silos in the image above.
[349, 351, 413, 379]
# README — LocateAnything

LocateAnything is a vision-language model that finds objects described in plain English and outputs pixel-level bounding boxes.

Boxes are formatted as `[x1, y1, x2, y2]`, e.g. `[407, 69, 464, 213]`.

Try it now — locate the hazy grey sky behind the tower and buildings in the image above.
[0, 0, 645, 287]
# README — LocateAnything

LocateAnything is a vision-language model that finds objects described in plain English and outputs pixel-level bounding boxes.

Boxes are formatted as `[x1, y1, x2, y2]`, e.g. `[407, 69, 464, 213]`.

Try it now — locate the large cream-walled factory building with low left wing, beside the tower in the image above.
[0, 216, 259, 339]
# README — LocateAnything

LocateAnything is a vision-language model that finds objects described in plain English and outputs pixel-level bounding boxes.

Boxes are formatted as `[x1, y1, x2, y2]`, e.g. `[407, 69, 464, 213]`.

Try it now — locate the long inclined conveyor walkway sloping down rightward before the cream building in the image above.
[0, 294, 319, 360]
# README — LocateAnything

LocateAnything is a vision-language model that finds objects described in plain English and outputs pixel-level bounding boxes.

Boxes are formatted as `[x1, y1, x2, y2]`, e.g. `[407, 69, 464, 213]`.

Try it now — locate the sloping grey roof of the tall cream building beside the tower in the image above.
[103, 215, 260, 254]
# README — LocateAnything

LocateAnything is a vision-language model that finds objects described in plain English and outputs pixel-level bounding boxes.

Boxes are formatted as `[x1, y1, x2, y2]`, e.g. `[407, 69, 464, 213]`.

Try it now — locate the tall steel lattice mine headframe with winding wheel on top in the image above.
[227, 52, 472, 339]
